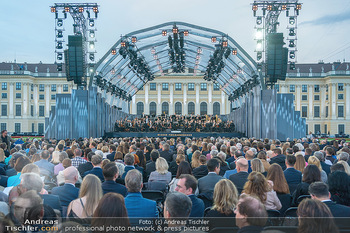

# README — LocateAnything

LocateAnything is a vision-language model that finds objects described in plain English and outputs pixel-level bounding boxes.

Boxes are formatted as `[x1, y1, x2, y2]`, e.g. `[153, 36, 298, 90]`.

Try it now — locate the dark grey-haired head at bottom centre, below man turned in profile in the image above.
[164, 192, 192, 225]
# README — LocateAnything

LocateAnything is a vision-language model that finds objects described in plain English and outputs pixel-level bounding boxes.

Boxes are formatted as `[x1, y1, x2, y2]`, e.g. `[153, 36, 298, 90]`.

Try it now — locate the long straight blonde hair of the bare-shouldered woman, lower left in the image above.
[79, 174, 103, 216]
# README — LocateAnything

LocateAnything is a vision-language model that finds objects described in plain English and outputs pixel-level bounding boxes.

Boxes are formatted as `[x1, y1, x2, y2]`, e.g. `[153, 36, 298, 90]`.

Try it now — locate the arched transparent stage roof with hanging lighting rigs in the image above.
[93, 22, 259, 100]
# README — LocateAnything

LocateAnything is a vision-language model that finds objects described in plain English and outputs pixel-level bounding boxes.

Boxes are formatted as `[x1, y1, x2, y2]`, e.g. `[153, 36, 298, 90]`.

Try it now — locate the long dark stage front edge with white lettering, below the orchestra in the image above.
[105, 131, 244, 138]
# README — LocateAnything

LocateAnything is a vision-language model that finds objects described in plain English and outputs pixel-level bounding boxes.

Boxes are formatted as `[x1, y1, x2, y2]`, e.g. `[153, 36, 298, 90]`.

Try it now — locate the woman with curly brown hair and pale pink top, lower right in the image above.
[243, 171, 282, 210]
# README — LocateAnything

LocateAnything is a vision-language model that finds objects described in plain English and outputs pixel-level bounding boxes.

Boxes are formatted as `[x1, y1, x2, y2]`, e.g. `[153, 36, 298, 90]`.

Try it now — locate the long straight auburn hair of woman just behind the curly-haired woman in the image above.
[266, 163, 293, 194]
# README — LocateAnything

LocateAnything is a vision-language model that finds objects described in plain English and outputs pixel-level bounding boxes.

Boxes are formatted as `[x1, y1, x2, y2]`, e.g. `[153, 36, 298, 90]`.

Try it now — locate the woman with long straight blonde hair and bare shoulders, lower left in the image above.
[67, 174, 103, 222]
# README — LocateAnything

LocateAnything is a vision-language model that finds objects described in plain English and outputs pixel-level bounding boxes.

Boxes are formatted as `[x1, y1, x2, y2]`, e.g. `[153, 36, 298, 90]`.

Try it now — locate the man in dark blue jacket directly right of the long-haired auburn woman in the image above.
[283, 155, 302, 194]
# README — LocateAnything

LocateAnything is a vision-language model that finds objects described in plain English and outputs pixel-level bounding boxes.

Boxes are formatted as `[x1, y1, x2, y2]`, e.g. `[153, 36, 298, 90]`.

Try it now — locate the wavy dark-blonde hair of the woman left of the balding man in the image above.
[213, 179, 238, 215]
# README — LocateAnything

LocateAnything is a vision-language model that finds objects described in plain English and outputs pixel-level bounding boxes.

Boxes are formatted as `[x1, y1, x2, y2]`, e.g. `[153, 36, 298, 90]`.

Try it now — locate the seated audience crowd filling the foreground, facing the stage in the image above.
[0, 130, 350, 232]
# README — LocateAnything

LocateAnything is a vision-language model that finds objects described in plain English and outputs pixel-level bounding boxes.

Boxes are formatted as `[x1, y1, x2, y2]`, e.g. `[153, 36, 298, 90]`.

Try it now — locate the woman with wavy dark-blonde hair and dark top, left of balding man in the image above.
[205, 179, 238, 230]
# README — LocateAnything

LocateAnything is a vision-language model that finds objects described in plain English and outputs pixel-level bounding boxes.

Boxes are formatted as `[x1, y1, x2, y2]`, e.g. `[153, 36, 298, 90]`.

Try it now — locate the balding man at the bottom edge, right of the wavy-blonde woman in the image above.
[234, 194, 268, 233]
